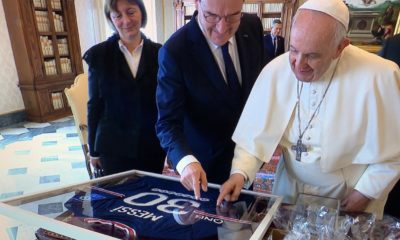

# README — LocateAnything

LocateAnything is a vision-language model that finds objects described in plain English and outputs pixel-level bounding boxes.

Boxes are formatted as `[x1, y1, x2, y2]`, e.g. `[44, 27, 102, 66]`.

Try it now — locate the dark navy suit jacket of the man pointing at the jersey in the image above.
[156, 12, 264, 183]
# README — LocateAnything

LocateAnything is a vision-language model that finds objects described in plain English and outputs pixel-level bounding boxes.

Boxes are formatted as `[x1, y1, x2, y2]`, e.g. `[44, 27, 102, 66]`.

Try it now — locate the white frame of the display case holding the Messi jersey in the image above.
[0, 170, 282, 240]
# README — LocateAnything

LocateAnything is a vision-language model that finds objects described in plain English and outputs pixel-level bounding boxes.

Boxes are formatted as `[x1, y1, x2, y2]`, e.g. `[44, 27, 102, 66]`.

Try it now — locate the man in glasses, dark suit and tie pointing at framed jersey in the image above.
[156, 0, 265, 197]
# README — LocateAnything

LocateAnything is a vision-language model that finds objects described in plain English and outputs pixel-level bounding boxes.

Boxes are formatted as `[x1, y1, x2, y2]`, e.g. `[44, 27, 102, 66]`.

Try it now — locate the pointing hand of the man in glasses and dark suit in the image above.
[181, 162, 208, 199]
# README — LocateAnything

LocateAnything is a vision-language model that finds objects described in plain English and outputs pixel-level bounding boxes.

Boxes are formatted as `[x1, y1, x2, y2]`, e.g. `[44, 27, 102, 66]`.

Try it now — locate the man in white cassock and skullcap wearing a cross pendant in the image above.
[217, 0, 400, 218]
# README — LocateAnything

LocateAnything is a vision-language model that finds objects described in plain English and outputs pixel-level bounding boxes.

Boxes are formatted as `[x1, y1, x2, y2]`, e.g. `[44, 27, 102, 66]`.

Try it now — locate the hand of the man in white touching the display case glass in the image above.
[217, 173, 244, 206]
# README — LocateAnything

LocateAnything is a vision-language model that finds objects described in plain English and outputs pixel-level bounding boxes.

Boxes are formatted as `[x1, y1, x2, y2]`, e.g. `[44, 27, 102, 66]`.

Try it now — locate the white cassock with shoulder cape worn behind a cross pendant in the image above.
[231, 45, 400, 218]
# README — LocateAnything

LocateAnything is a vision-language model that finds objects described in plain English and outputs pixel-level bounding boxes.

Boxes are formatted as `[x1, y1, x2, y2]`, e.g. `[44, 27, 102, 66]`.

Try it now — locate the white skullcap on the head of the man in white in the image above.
[299, 0, 350, 31]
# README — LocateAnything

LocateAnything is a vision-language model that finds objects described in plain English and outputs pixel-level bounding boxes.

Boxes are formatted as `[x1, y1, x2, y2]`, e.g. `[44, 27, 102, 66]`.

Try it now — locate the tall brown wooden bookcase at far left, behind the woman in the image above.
[2, 0, 83, 122]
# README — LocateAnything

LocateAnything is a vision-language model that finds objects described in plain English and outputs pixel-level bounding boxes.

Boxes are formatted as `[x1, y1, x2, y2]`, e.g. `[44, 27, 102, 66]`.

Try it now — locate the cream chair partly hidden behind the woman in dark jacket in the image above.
[64, 73, 94, 179]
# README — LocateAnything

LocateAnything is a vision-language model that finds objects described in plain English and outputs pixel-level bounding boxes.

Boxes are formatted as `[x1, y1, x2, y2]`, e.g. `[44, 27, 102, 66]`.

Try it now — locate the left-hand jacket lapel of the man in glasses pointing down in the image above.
[188, 11, 238, 109]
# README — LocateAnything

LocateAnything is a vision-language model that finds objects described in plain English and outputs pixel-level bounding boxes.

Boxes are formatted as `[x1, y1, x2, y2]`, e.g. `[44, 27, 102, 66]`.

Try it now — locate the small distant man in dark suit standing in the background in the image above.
[264, 19, 285, 63]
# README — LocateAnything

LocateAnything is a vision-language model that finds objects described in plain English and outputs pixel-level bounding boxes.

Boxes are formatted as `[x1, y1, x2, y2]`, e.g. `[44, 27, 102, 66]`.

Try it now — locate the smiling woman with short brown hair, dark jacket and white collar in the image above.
[83, 0, 165, 175]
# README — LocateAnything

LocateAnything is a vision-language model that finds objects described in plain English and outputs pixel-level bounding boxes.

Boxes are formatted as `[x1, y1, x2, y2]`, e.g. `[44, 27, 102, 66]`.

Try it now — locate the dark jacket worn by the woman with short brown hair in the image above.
[83, 35, 165, 172]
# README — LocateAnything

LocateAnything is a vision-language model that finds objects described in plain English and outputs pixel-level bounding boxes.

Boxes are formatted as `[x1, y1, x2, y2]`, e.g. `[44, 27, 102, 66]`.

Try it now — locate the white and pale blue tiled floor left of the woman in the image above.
[0, 117, 89, 240]
